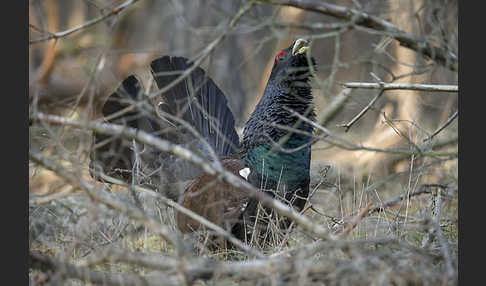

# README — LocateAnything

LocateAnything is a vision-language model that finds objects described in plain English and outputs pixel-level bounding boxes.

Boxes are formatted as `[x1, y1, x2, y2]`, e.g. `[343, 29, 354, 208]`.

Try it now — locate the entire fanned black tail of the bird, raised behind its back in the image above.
[90, 56, 239, 188]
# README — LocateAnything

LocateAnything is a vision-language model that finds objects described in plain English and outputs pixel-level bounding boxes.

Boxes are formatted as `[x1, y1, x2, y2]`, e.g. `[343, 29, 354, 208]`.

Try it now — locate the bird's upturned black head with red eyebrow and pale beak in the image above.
[269, 39, 316, 82]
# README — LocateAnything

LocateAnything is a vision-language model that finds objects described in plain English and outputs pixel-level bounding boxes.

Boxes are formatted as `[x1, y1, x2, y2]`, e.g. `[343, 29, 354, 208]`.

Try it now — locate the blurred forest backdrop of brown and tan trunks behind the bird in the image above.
[29, 0, 458, 177]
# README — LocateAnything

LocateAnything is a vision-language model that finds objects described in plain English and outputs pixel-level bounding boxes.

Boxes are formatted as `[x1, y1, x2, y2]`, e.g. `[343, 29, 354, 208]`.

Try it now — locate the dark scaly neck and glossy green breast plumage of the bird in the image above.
[243, 77, 315, 184]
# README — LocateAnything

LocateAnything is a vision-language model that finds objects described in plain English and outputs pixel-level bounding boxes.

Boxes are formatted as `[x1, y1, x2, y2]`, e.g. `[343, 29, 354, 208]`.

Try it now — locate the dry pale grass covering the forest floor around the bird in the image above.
[29, 134, 458, 285]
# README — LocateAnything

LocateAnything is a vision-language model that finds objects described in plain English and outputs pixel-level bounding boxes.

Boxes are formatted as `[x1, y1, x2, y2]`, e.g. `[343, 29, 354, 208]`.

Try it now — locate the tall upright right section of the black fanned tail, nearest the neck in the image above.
[150, 56, 239, 156]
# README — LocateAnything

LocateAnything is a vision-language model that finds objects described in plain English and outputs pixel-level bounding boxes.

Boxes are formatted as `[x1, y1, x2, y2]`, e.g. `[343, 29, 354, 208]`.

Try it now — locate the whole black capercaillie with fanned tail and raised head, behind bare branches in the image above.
[90, 38, 316, 249]
